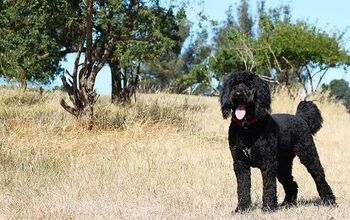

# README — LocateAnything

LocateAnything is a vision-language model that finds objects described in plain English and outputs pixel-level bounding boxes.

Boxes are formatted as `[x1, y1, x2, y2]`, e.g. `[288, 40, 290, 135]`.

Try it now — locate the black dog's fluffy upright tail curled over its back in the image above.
[296, 101, 323, 134]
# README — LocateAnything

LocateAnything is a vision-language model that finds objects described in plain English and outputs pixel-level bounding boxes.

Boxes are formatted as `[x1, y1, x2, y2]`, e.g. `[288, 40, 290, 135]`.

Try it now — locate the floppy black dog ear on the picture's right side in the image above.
[254, 76, 271, 118]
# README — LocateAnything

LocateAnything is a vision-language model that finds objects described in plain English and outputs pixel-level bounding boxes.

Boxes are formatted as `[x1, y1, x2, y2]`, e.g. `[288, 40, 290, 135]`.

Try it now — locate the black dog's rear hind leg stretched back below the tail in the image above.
[294, 137, 336, 205]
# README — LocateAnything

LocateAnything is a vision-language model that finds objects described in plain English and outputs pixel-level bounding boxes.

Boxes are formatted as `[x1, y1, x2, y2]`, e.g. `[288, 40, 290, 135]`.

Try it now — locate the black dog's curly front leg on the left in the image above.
[233, 160, 252, 212]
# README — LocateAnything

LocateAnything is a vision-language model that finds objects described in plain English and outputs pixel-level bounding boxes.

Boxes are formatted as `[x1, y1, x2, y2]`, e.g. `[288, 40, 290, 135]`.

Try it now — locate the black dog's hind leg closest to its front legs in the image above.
[277, 157, 298, 206]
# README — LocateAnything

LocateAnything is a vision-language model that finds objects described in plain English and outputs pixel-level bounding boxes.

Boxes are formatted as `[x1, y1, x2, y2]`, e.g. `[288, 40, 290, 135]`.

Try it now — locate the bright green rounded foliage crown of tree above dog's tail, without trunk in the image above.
[259, 22, 348, 67]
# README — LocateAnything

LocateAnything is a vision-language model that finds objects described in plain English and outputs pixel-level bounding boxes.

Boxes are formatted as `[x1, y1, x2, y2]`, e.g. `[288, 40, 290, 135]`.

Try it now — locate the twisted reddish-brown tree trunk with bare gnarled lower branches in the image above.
[61, 0, 108, 130]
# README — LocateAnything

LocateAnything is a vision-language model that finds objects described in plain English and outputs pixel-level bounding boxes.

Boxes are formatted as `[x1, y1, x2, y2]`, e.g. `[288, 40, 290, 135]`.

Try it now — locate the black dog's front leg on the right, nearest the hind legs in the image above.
[261, 161, 278, 211]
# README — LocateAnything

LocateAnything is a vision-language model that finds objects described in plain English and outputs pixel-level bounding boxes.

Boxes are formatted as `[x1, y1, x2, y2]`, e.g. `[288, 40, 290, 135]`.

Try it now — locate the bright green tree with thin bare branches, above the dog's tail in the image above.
[256, 16, 350, 94]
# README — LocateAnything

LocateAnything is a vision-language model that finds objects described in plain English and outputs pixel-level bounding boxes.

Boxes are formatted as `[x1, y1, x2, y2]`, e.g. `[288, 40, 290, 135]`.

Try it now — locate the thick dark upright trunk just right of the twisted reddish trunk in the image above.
[109, 59, 122, 103]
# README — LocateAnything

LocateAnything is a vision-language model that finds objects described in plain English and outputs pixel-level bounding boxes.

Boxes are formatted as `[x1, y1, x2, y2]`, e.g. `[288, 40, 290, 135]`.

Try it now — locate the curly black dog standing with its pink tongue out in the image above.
[220, 72, 335, 212]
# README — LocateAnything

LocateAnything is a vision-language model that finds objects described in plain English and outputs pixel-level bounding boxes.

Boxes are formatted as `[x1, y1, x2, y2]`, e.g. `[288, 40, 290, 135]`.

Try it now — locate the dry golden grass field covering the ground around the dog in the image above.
[0, 88, 350, 219]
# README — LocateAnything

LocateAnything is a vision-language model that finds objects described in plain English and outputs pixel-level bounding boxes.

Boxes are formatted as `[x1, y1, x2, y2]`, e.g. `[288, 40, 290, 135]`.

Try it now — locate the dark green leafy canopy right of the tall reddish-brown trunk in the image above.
[94, 0, 186, 66]
